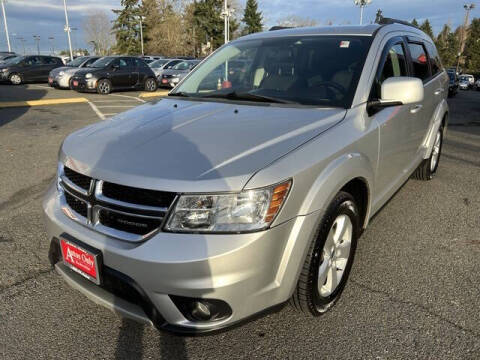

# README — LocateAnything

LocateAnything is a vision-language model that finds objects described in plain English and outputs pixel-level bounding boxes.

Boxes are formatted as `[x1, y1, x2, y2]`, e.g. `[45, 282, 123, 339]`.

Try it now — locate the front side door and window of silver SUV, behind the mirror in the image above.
[369, 37, 416, 198]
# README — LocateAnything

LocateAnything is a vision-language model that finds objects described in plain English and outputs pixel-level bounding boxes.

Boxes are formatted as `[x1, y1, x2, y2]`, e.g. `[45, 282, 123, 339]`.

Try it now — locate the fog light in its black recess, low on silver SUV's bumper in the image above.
[170, 295, 232, 322]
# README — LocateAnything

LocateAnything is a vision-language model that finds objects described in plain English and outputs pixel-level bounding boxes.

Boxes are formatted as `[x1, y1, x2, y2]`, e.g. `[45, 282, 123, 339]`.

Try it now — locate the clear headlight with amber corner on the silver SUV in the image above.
[165, 180, 291, 233]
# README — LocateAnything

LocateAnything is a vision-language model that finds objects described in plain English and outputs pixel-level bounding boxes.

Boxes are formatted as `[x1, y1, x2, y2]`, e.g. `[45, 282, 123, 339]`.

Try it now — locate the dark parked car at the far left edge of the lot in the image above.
[0, 55, 63, 85]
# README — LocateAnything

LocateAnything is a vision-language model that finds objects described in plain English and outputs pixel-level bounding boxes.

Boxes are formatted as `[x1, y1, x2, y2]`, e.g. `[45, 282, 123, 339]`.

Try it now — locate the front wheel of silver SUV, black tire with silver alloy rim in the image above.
[290, 191, 360, 316]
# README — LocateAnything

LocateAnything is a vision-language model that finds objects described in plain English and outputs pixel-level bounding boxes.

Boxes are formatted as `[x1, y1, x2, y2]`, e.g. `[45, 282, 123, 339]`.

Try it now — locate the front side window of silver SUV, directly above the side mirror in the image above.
[370, 43, 408, 99]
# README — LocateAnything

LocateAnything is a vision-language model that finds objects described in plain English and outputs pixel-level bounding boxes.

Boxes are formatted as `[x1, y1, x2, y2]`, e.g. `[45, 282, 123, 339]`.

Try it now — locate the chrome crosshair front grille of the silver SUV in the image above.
[59, 167, 176, 242]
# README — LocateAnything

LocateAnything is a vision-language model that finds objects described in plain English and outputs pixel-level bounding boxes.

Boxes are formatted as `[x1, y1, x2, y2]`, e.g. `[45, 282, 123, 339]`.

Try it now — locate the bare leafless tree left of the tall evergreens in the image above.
[83, 10, 114, 56]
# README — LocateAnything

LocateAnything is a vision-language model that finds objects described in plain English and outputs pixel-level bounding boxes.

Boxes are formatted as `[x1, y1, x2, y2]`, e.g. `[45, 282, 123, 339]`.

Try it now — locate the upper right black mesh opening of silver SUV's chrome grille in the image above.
[102, 182, 175, 208]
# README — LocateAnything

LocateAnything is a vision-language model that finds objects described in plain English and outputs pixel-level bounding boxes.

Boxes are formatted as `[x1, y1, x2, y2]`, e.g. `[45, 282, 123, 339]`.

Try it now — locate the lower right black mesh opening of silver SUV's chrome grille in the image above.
[98, 209, 163, 235]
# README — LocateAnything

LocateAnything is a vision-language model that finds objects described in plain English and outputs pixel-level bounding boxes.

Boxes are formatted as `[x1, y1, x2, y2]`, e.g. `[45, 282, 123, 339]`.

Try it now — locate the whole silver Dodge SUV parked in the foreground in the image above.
[43, 21, 448, 333]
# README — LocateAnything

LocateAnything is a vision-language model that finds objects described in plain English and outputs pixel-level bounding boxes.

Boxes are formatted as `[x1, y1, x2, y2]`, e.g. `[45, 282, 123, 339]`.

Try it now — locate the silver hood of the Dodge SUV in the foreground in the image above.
[60, 98, 346, 192]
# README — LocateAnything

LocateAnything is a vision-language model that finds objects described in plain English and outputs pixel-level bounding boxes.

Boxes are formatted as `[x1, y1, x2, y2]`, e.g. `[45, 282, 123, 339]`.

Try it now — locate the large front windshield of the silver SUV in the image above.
[171, 35, 371, 108]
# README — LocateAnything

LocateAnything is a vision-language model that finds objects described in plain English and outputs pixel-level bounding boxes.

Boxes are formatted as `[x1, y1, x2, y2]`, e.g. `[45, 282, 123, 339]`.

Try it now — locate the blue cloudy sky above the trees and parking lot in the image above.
[0, 0, 480, 53]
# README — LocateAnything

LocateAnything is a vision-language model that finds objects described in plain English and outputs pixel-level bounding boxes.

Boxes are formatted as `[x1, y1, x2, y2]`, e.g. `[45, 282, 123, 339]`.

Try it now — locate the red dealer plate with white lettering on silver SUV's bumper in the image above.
[60, 234, 102, 285]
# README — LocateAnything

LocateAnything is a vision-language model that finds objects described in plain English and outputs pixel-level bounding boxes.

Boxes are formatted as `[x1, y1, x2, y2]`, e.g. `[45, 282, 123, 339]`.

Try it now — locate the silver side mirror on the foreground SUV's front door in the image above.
[368, 76, 424, 109]
